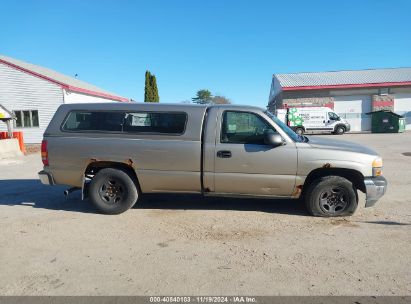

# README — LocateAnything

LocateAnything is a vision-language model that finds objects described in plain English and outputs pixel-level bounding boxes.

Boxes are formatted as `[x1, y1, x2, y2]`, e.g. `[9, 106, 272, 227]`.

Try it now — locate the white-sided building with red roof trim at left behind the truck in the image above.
[0, 55, 129, 144]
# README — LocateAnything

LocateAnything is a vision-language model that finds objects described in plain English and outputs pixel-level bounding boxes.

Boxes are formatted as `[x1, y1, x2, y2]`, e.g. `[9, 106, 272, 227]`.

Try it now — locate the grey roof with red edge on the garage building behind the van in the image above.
[273, 68, 411, 91]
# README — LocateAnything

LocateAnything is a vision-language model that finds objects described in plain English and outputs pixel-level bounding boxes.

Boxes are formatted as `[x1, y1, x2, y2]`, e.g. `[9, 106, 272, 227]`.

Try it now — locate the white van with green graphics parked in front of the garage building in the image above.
[277, 107, 350, 135]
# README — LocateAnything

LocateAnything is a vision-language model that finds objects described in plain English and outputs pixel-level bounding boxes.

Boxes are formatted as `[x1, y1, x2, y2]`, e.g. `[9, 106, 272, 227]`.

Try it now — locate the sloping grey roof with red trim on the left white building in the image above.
[0, 55, 129, 102]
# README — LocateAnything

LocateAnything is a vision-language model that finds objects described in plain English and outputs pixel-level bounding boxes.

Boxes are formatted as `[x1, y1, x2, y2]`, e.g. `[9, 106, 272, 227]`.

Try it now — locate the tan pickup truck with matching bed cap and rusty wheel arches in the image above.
[39, 103, 387, 216]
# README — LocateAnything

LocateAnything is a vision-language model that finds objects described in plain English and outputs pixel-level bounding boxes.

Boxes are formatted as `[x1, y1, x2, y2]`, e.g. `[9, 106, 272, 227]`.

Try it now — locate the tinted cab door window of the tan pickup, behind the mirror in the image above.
[221, 111, 276, 145]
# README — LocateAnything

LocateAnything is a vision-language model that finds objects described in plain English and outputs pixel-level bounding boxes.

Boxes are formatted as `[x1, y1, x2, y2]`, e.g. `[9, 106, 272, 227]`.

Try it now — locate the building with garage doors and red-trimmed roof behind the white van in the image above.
[268, 68, 411, 131]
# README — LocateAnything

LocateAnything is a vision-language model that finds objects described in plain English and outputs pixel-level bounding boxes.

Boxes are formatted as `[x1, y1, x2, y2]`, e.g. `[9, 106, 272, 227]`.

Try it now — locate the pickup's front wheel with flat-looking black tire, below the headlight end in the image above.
[304, 176, 358, 217]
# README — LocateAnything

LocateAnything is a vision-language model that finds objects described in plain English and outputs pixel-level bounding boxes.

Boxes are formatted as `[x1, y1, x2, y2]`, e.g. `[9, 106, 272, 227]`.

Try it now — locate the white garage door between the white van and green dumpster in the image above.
[334, 95, 371, 131]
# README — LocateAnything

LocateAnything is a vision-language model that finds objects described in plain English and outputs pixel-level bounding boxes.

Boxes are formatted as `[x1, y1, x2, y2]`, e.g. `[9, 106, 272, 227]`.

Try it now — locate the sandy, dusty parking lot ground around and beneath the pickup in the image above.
[0, 132, 411, 295]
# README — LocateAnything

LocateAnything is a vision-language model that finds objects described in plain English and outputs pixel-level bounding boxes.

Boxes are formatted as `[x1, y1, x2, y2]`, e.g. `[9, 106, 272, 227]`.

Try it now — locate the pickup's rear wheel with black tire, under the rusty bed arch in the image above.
[89, 168, 138, 214]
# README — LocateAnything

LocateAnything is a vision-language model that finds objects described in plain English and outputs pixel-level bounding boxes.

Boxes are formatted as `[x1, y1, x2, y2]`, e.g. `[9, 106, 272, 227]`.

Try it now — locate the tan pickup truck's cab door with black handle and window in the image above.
[214, 109, 297, 196]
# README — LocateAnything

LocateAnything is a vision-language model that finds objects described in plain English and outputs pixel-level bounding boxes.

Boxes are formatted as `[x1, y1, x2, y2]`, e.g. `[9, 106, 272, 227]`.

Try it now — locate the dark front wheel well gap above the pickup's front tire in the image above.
[302, 166, 366, 196]
